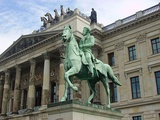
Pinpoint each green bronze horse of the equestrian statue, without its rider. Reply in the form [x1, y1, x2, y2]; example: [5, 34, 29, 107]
[61, 26, 121, 108]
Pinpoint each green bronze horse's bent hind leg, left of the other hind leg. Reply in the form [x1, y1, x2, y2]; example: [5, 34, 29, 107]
[87, 80, 96, 103]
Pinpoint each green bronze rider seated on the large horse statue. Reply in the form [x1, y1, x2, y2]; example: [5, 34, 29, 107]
[79, 27, 95, 77]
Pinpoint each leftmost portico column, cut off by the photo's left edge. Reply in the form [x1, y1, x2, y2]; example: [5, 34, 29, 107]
[0, 75, 4, 113]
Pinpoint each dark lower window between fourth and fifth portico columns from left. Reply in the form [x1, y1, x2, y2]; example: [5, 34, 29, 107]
[35, 86, 42, 106]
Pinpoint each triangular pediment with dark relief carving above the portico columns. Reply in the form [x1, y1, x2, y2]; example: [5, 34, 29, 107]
[0, 30, 61, 60]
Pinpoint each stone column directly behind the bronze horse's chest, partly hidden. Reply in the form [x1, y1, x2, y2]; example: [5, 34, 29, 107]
[58, 48, 65, 101]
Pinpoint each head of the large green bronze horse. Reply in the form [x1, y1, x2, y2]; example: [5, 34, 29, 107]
[62, 25, 72, 42]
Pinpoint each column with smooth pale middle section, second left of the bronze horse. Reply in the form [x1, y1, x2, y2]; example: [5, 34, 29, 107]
[41, 53, 50, 107]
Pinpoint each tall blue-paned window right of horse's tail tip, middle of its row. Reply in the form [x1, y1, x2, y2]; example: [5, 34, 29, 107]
[131, 76, 141, 99]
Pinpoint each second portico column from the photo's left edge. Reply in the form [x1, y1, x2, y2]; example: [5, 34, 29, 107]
[1, 70, 10, 115]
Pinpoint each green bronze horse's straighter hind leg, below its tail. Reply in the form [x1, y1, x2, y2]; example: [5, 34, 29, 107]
[101, 78, 111, 108]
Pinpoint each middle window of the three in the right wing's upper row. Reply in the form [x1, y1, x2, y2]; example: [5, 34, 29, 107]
[128, 45, 136, 61]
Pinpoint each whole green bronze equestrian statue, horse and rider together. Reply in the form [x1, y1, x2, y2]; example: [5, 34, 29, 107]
[61, 25, 121, 108]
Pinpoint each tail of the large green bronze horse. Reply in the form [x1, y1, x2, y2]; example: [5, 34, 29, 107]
[105, 64, 121, 86]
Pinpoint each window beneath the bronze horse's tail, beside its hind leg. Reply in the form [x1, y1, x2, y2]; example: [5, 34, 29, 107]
[109, 82, 118, 103]
